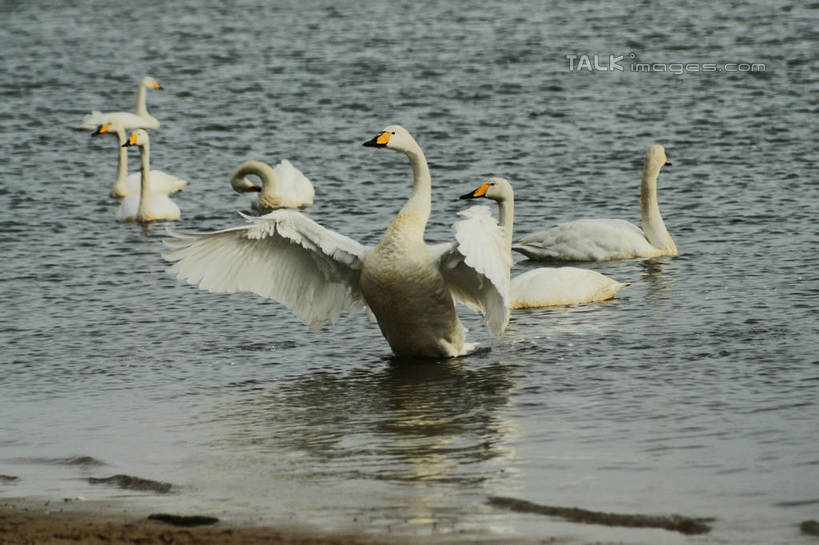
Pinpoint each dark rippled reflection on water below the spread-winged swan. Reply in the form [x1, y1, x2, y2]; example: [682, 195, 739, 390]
[201, 359, 513, 485]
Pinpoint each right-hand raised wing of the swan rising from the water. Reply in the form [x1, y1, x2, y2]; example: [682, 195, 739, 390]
[433, 206, 512, 336]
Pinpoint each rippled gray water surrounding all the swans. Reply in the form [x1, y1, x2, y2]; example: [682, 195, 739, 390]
[0, 0, 819, 544]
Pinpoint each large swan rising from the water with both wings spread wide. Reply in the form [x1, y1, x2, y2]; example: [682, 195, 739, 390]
[164, 125, 511, 357]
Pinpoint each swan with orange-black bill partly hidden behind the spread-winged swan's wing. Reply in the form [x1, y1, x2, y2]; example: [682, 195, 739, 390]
[461, 177, 630, 310]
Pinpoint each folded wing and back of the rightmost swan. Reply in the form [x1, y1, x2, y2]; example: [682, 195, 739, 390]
[512, 219, 652, 261]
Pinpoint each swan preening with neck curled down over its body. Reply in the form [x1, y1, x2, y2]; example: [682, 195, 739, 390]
[230, 159, 315, 211]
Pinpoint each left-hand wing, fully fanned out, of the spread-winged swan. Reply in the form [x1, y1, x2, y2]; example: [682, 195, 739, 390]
[163, 210, 368, 329]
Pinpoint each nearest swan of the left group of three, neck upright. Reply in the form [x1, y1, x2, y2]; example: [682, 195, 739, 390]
[117, 129, 180, 223]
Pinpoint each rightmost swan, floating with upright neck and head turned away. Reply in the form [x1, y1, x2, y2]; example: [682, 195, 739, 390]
[512, 144, 677, 261]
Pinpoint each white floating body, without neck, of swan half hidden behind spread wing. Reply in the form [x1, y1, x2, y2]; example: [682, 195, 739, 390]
[510, 267, 630, 309]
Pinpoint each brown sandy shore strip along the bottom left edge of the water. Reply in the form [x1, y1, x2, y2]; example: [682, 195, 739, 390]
[0, 500, 398, 545]
